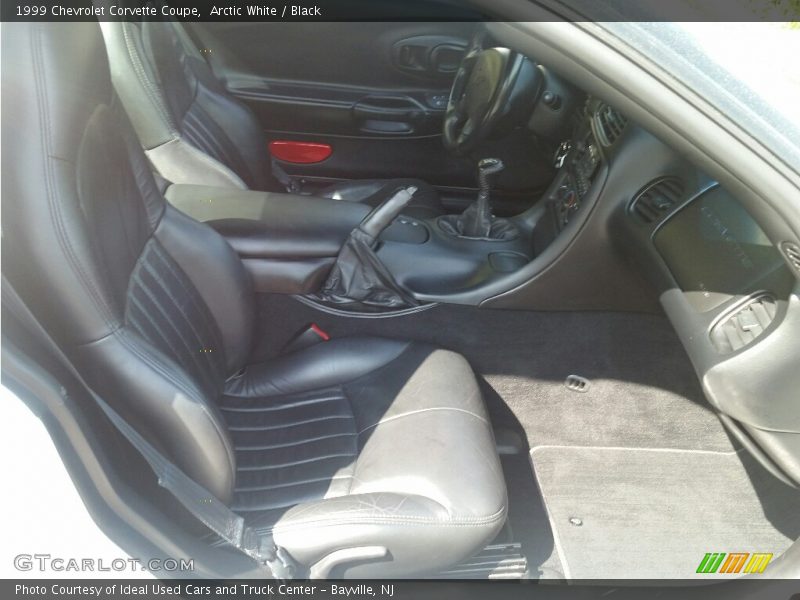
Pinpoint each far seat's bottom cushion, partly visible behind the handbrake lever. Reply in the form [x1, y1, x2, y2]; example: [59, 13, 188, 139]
[317, 179, 444, 219]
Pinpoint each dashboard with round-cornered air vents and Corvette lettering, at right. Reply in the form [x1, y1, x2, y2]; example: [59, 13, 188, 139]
[576, 98, 800, 486]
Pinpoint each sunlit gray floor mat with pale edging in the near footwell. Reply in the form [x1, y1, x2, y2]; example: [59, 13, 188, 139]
[531, 446, 800, 579]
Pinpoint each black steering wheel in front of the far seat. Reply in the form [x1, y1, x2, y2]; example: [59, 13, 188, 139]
[443, 30, 542, 155]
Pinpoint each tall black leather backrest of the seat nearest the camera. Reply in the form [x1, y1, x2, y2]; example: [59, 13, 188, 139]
[2, 23, 255, 501]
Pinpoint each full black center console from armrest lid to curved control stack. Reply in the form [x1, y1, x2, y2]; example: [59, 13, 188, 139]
[161, 100, 610, 311]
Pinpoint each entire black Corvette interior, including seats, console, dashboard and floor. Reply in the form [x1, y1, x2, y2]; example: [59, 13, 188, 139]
[2, 9, 800, 580]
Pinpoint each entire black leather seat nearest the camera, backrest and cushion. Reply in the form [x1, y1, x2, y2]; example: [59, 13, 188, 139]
[2, 23, 506, 577]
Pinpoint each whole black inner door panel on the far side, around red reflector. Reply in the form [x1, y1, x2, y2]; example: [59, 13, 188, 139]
[192, 22, 476, 187]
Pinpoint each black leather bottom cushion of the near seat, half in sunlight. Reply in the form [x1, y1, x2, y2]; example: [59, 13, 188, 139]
[221, 338, 506, 577]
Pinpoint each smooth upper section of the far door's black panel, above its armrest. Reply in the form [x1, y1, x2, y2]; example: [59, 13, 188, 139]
[192, 22, 476, 91]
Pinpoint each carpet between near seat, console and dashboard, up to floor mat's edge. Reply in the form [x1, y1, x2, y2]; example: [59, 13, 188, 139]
[256, 295, 732, 451]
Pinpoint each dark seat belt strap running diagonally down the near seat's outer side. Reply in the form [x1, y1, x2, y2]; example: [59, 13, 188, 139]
[2, 275, 296, 579]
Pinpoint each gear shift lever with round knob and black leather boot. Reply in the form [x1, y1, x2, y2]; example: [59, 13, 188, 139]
[439, 158, 517, 240]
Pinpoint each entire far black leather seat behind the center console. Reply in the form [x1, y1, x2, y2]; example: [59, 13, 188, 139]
[97, 22, 443, 218]
